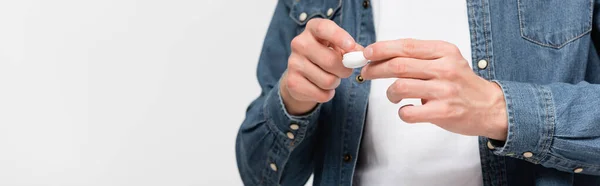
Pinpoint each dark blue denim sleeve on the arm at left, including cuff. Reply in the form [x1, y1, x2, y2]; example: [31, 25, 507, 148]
[236, 0, 320, 185]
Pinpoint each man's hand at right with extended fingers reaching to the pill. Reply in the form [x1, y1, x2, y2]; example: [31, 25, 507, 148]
[361, 39, 508, 140]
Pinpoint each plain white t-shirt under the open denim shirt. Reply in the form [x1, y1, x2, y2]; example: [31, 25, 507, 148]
[353, 0, 483, 186]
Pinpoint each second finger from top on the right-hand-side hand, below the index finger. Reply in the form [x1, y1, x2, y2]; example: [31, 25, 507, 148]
[361, 57, 439, 80]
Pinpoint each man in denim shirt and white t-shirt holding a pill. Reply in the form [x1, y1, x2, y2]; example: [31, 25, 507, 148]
[236, 0, 600, 186]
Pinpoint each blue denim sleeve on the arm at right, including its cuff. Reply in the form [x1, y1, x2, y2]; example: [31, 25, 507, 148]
[488, 2, 600, 175]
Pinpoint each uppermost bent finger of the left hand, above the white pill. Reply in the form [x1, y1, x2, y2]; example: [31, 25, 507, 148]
[306, 19, 356, 51]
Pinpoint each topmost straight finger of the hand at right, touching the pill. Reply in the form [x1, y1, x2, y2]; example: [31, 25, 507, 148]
[364, 39, 460, 61]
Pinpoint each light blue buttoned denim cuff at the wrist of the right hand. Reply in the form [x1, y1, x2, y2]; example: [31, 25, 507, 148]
[487, 81, 555, 164]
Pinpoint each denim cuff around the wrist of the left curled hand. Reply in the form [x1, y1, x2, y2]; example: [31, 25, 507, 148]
[264, 84, 321, 149]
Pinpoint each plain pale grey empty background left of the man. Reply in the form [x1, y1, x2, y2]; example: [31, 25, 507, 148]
[0, 0, 284, 186]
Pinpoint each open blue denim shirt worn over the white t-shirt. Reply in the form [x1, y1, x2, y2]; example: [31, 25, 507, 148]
[236, 0, 600, 186]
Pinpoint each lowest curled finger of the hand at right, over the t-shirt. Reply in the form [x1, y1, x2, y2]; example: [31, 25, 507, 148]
[398, 100, 450, 123]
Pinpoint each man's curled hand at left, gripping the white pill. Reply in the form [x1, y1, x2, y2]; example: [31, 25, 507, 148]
[280, 19, 362, 115]
